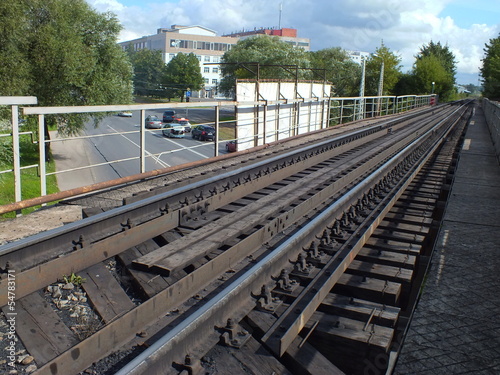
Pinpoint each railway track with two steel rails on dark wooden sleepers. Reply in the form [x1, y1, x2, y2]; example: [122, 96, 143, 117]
[0, 103, 471, 374]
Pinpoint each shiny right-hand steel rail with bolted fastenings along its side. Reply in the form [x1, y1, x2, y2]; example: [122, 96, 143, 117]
[112, 102, 468, 375]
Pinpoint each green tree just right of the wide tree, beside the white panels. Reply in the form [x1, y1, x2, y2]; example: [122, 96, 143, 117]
[309, 47, 361, 97]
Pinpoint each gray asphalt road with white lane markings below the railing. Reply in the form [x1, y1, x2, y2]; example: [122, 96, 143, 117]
[53, 108, 235, 190]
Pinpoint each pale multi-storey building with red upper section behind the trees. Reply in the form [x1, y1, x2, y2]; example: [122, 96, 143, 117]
[119, 25, 310, 98]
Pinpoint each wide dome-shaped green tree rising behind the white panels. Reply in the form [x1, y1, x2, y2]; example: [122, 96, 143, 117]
[220, 35, 312, 96]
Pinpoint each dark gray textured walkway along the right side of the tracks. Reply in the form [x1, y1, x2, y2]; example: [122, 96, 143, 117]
[393, 101, 500, 375]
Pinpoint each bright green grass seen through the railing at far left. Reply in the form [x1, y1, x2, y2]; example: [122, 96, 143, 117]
[0, 136, 59, 220]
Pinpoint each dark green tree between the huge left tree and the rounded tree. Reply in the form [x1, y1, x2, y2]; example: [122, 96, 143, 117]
[126, 44, 166, 97]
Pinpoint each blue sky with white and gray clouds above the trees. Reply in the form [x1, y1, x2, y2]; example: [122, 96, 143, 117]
[86, 0, 500, 85]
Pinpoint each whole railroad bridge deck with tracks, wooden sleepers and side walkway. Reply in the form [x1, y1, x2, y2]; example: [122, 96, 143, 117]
[0, 97, 500, 375]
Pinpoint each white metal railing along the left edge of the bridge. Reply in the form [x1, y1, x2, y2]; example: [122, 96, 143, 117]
[0, 95, 433, 206]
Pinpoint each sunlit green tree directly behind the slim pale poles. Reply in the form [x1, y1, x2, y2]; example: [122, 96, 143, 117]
[365, 42, 402, 96]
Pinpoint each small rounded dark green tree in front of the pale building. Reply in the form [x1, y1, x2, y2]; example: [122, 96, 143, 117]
[162, 53, 204, 101]
